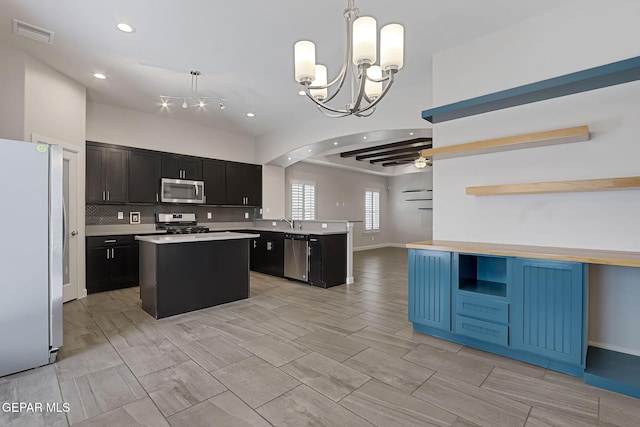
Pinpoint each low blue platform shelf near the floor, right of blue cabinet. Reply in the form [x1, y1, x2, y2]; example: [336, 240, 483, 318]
[584, 347, 640, 398]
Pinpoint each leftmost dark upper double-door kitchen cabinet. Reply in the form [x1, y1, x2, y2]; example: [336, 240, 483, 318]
[86, 143, 129, 203]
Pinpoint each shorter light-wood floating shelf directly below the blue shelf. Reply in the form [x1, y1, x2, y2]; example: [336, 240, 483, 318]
[421, 126, 590, 159]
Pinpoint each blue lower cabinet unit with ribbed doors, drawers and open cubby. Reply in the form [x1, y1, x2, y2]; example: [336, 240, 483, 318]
[409, 249, 587, 376]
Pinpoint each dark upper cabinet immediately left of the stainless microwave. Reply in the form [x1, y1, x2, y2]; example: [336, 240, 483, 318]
[129, 149, 162, 203]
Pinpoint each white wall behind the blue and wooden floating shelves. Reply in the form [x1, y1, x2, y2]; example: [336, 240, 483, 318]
[433, 0, 640, 354]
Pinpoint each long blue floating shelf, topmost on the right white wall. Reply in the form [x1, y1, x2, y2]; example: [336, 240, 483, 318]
[422, 56, 640, 123]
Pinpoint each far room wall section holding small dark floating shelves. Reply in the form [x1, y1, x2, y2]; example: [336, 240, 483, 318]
[389, 168, 433, 244]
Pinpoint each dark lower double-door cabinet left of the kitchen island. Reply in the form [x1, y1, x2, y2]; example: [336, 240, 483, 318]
[86, 235, 138, 294]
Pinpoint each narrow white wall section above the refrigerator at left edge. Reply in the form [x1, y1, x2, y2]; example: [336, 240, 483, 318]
[0, 46, 25, 141]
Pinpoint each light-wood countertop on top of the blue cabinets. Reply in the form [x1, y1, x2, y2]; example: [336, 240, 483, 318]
[406, 240, 640, 267]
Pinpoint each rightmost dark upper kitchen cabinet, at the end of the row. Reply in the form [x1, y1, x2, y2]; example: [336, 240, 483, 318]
[226, 162, 262, 206]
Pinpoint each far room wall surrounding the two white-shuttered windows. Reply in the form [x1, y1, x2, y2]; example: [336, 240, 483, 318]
[285, 162, 393, 248]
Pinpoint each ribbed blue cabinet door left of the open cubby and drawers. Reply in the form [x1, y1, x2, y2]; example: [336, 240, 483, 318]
[409, 249, 451, 331]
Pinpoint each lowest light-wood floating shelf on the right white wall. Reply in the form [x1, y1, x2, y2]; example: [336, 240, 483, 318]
[466, 176, 640, 196]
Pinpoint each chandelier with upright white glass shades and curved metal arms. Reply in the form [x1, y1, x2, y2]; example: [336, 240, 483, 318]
[294, 0, 404, 117]
